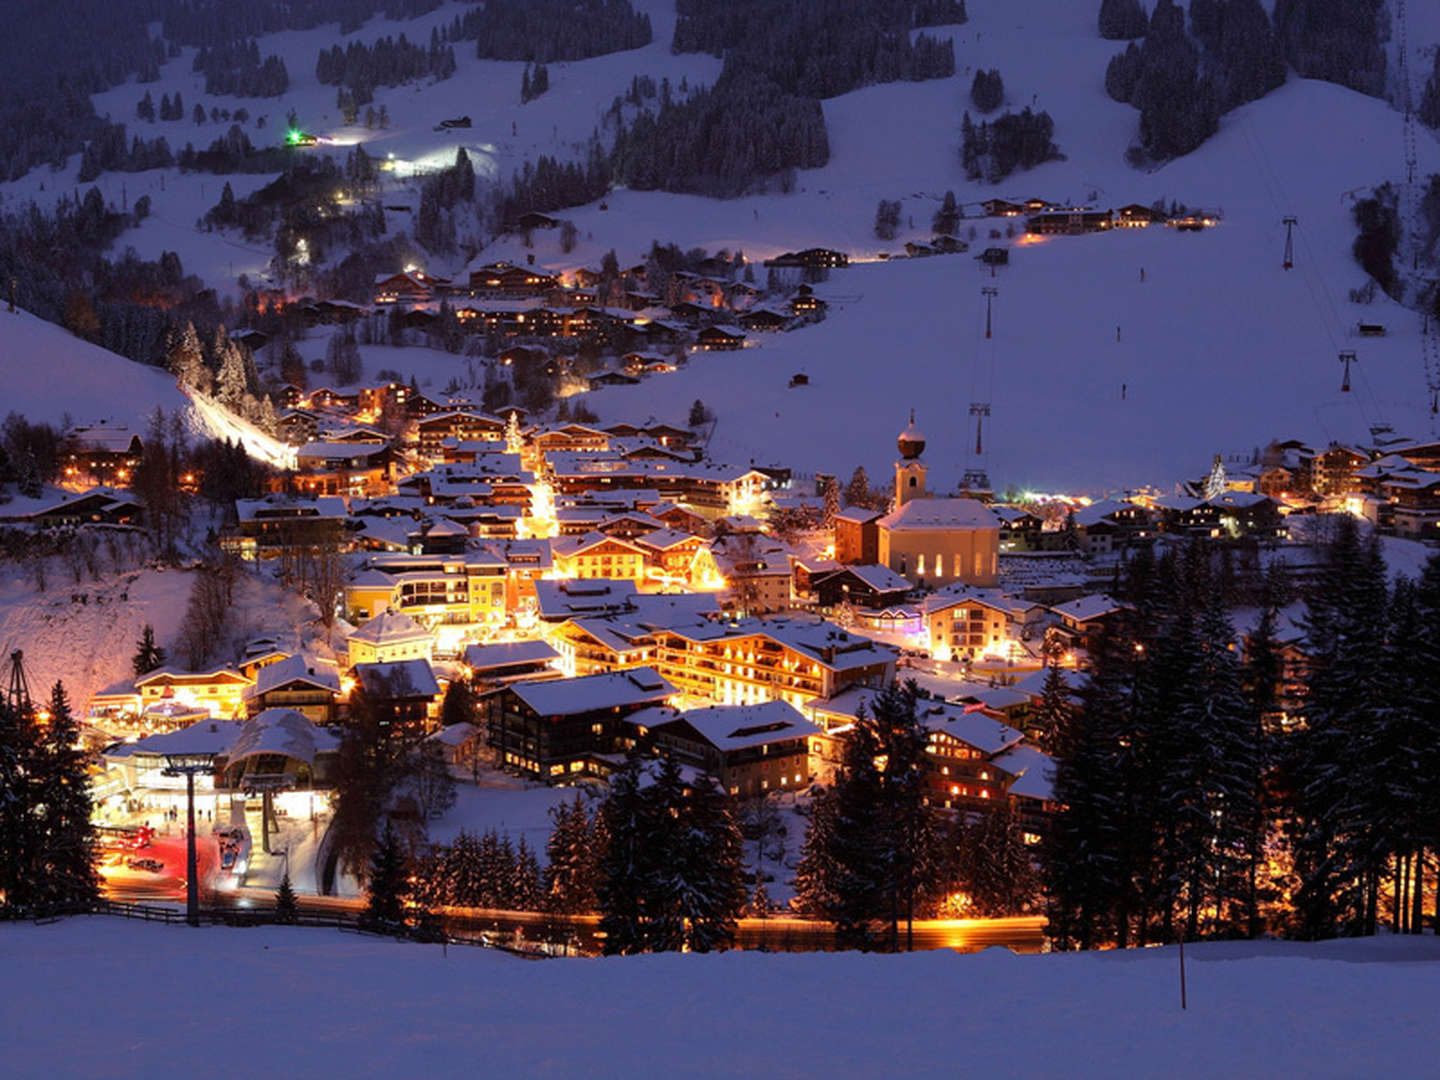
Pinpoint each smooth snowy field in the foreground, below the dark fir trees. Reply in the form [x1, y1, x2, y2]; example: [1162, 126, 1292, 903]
[0, 919, 1440, 1080]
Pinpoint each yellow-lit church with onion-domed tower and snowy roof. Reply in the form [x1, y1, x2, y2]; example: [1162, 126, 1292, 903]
[878, 412, 999, 588]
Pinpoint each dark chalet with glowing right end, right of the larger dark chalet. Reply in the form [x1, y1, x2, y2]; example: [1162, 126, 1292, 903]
[645, 701, 834, 798]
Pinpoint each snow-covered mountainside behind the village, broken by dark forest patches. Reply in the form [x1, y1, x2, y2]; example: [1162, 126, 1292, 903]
[0, 0, 1440, 490]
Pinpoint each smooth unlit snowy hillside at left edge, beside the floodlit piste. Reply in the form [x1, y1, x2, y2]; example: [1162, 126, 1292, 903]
[0, 308, 187, 432]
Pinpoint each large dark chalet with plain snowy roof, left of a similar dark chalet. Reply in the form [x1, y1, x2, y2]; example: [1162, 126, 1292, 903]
[481, 667, 675, 783]
